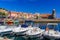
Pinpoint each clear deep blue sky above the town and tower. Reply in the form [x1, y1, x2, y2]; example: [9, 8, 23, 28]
[0, 0, 60, 18]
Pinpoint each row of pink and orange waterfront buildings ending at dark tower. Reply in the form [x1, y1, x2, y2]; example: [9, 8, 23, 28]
[0, 9, 56, 19]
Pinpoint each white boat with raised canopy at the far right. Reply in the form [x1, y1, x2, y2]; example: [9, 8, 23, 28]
[43, 23, 60, 39]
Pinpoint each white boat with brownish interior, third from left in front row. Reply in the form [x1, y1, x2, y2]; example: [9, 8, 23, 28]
[26, 26, 44, 38]
